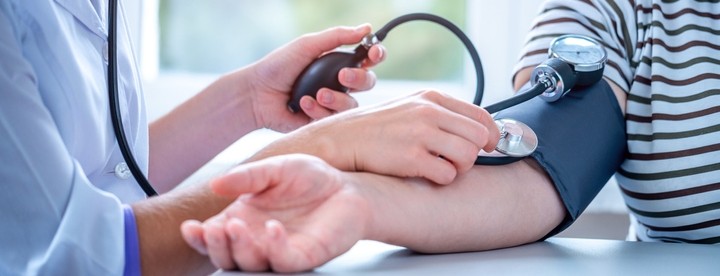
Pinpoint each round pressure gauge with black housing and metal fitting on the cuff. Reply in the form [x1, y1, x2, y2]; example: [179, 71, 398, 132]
[530, 34, 607, 102]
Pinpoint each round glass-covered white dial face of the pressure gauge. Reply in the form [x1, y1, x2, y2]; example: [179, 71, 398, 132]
[550, 35, 607, 71]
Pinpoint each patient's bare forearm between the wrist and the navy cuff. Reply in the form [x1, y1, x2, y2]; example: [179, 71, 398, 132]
[357, 161, 565, 253]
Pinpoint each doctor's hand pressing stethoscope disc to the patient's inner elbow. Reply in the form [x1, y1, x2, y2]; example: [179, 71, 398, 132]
[253, 91, 500, 184]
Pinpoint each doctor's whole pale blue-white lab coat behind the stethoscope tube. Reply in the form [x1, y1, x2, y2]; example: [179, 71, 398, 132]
[0, 0, 148, 275]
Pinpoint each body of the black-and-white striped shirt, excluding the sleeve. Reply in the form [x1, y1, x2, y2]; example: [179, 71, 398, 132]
[616, 0, 720, 244]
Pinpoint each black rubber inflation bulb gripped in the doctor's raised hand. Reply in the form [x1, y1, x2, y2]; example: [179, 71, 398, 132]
[288, 45, 368, 113]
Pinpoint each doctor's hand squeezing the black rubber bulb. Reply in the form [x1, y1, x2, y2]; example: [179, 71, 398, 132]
[249, 24, 385, 132]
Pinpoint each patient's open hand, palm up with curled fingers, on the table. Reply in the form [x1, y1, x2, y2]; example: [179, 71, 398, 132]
[181, 155, 370, 272]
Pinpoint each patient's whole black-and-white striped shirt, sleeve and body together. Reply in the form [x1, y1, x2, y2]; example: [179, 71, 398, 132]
[515, 0, 720, 243]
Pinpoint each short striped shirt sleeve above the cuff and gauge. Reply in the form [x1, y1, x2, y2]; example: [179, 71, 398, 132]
[513, 0, 637, 91]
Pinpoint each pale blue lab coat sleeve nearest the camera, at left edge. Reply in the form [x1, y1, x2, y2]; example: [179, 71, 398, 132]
[0, 4, 125, 275]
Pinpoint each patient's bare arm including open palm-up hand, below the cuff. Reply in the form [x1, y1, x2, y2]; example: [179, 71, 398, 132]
[183, 70, 624, 272]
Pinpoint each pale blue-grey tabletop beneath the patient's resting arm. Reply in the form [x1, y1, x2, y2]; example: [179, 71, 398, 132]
[216, 238, 720, 276]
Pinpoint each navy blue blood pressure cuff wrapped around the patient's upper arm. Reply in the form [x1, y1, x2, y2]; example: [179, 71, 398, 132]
[495, 80, 626, 238]
